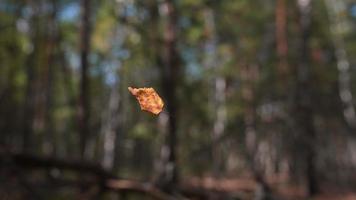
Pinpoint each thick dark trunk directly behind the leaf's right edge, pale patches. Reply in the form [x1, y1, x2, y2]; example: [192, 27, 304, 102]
[157, 0, 180, 192]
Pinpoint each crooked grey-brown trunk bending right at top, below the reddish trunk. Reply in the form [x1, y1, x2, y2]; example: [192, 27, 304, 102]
[241, 19, 274, 200]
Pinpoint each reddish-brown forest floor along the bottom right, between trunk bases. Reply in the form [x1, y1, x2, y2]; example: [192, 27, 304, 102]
[183, 177, 356, 200]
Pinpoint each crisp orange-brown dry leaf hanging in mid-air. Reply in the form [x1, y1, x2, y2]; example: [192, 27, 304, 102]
[128, 87, 164, 115]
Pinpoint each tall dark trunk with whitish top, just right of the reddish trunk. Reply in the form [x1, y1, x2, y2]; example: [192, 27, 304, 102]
[294, 0, 319, 196]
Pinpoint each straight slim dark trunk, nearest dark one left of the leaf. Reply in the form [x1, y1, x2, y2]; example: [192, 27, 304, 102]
[78, 0, 90, 158]
